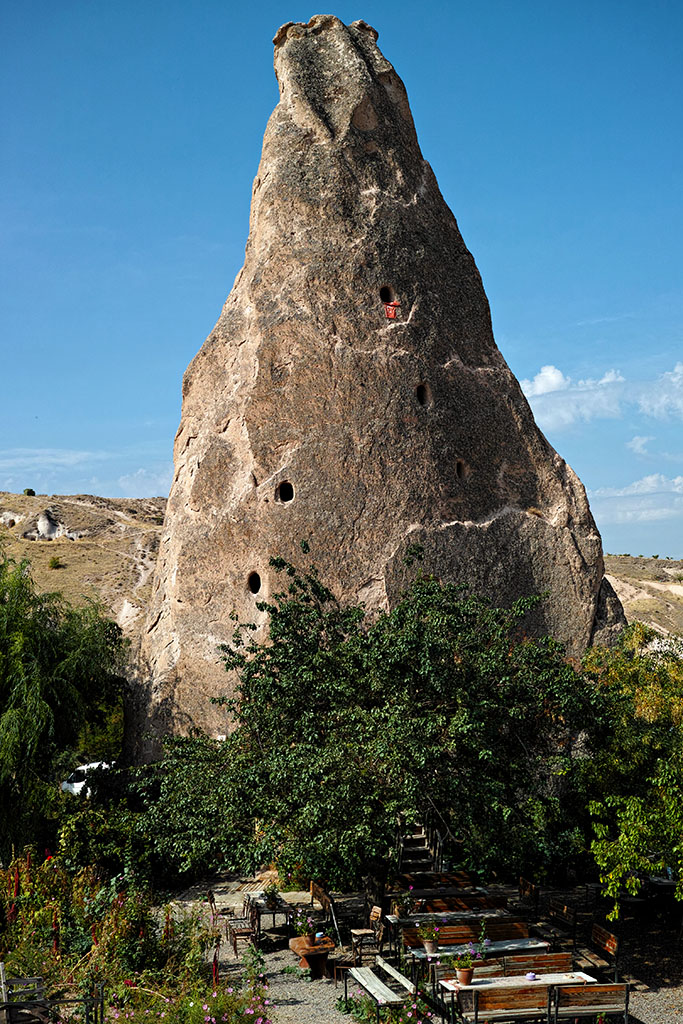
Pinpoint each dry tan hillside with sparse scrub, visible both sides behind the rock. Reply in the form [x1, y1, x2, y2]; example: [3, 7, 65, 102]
[0, 492, 683, 636]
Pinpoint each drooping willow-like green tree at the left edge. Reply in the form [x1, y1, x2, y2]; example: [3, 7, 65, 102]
[0, 552, 125, 859]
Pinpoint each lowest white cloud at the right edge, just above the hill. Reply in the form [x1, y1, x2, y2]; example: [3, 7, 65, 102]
[589, 473, 683, 524]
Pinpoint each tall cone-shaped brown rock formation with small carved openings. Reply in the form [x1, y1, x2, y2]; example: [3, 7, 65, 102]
[136, 15, 624, 753]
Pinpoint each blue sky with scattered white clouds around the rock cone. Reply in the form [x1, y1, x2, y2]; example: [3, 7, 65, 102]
[0, 0, 683, 557]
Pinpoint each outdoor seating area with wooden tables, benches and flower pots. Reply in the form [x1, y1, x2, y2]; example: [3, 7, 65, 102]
[192, 856, 683, 1024]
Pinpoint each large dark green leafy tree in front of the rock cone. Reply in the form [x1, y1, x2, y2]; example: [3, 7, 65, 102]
[205, 559, 603, 885]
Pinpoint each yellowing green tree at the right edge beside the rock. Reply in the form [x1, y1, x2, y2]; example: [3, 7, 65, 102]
[585, 623, 683, 918]
